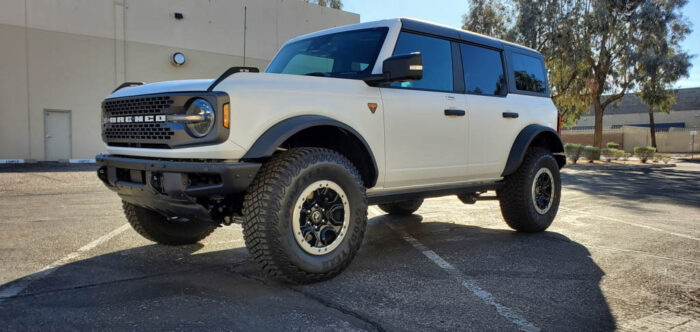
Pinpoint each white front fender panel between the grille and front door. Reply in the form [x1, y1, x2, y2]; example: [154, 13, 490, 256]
[217, 73, 385, 186]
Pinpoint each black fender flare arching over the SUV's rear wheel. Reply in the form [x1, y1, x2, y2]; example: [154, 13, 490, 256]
[501, 124, 566, 177]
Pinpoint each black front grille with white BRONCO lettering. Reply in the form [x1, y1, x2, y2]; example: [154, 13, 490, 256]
[102, 91, 229, 149]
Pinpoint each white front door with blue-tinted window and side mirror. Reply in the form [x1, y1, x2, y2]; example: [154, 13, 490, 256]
[381, 32, 468, 188]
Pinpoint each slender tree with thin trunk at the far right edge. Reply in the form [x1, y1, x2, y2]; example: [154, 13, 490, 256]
[635, 0, 690, 147]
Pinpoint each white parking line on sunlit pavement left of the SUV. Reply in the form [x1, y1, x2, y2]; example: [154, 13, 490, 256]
[0, 224, 129, 303]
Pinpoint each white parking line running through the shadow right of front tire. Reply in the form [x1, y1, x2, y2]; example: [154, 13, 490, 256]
[369, 206, 540, 332]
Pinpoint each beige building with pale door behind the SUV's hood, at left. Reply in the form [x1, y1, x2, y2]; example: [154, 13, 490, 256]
[0, 0, 360, 161]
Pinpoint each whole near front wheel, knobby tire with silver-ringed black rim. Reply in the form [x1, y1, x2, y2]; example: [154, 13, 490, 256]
[243, 148, 367, 284]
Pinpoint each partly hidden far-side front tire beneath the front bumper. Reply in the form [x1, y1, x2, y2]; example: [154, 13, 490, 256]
[122, 201, 216, 246]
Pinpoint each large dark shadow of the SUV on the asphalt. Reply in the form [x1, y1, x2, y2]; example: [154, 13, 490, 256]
[0, 215, 615, 331]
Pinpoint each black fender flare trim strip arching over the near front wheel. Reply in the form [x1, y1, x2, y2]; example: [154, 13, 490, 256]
[241, 115, 379, 188]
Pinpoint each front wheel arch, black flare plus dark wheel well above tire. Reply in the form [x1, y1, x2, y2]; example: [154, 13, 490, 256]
[242, 115, 379, 188]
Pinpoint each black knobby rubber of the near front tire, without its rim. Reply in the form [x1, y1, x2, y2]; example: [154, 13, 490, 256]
[243, 147, 367, 284]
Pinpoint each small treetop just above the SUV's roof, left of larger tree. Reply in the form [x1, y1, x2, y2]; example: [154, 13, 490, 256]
[462, 0, 510, 39]
